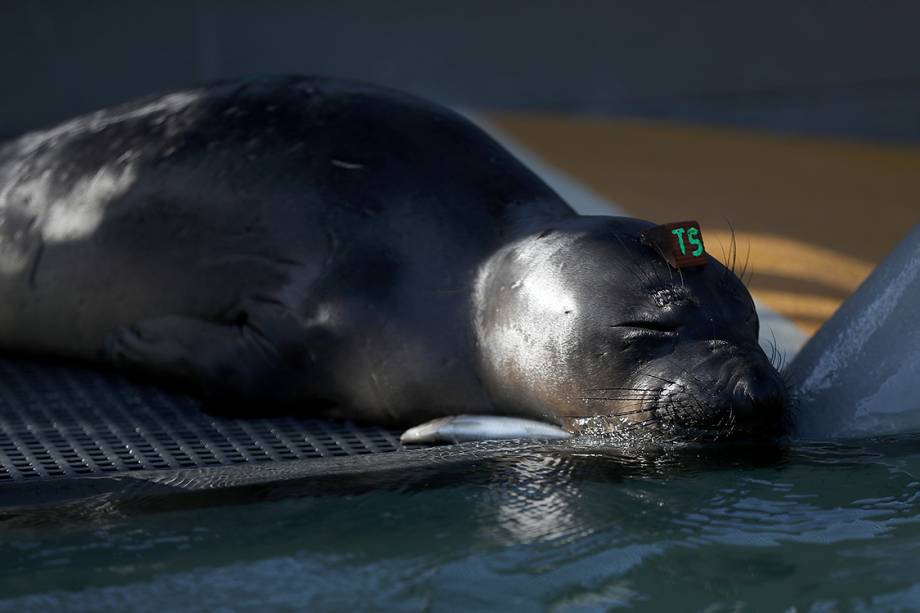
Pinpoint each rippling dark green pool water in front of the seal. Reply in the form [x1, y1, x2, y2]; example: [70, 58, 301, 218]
[0, 436, 920, 611]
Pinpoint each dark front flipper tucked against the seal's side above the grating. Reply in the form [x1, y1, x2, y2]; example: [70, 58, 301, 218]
[103, 298, 306, 412]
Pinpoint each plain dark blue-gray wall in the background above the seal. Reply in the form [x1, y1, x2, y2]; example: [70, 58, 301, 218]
[0, 0, 920, 140]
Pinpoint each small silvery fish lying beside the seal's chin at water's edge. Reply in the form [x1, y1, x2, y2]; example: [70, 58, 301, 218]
[399, 415, 572, 445]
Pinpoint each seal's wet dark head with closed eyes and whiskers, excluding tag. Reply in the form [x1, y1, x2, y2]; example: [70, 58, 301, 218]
[476, 217, 788, 440]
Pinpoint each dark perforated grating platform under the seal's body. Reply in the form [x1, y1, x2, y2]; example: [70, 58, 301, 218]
[0, 358, 401, 483]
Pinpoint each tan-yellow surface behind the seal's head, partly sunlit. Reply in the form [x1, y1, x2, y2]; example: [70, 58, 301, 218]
[488, 113, 920, 334]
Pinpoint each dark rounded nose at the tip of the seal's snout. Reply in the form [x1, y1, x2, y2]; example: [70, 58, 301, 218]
[732, 372, 787, 437]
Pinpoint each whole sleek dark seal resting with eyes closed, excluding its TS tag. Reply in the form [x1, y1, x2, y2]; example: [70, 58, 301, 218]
[0, 77, 786, 438]
